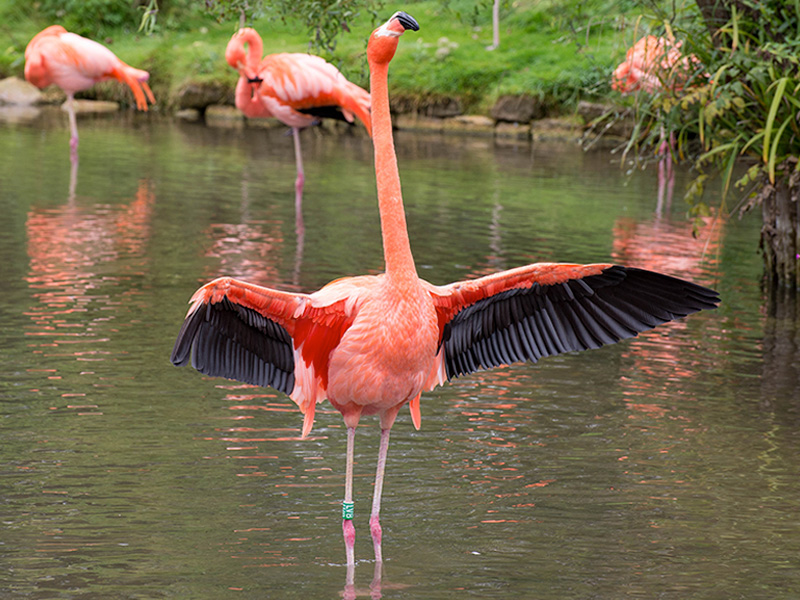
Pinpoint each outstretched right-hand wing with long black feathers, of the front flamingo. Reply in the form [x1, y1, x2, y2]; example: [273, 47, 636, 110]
[424, 263, 719, 380]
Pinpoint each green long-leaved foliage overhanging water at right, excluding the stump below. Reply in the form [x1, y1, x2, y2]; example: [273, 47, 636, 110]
[608, 0, 800, 216]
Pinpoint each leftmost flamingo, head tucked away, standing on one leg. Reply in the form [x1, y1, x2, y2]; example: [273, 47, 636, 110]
[25, 25, 156, 160]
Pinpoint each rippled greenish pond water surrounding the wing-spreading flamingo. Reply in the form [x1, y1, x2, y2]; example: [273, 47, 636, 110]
[0, 109, 800, 599]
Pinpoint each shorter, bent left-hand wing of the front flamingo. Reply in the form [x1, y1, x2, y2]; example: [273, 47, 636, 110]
[171, 277, 376, 437]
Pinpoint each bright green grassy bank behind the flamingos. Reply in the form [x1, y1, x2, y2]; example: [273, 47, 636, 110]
[0, 0, 631, 114]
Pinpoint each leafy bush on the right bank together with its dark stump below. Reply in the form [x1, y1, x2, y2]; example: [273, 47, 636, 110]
[608, 0, 800, 289]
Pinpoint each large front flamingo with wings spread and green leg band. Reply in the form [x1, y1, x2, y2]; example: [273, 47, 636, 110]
[171, 12, 719, 580]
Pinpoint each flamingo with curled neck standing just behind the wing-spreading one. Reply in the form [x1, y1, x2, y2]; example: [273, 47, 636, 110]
[225, 27, 371, 209]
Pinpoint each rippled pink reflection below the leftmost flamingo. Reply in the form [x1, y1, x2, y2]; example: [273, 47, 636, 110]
[25, 178, 155, 360]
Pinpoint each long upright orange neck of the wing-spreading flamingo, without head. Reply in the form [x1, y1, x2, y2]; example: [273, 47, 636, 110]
[370, 63, 417, 278]
